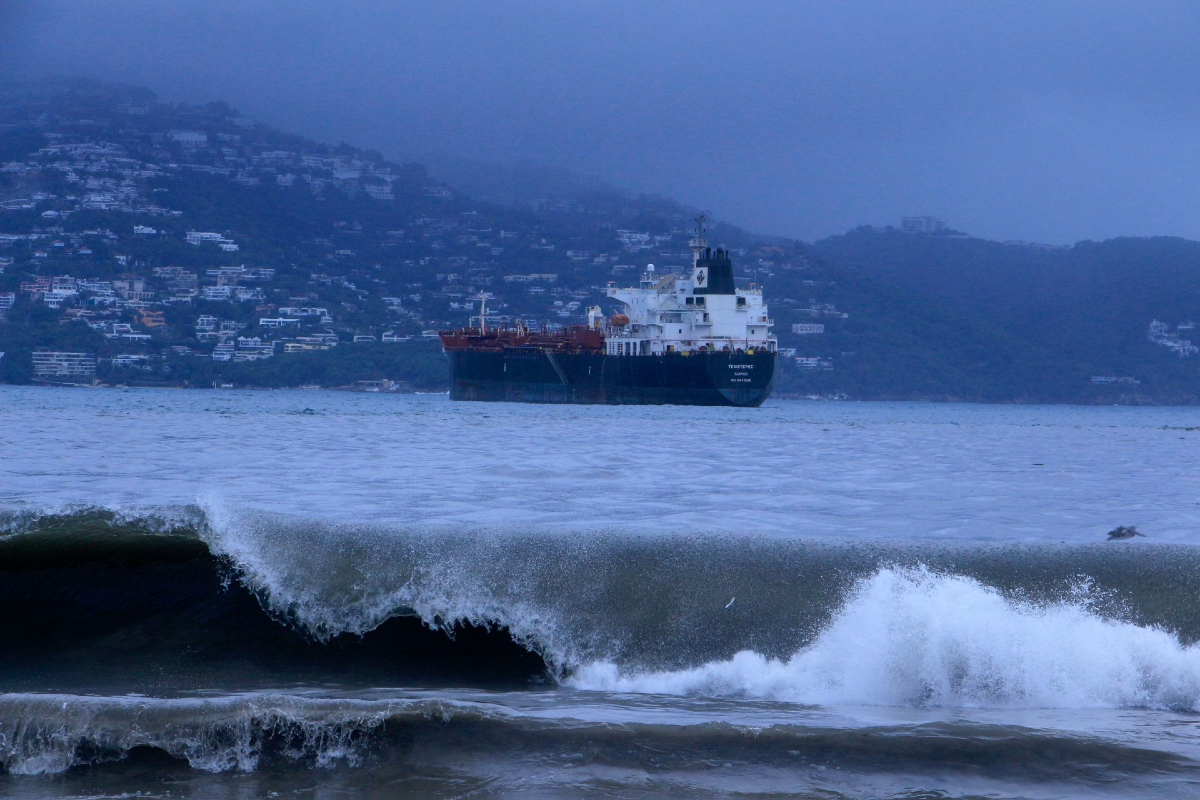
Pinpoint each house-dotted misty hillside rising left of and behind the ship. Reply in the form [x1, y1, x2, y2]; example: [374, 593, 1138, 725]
[0, 82, 751, 389]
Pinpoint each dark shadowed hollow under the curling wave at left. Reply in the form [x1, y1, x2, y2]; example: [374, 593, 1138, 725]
[0, 510, 546, 693]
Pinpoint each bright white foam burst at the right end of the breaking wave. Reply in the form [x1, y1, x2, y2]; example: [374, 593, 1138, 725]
[569, 569, 1200, 710]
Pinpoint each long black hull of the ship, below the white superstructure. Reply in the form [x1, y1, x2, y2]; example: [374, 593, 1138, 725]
[446, 348, 775, 408]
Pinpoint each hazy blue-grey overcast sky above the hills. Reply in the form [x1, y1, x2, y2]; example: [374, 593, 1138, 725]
[0, 0, 1200, 243]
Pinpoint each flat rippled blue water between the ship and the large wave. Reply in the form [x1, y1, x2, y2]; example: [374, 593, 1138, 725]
[7, 387, 1200, 543]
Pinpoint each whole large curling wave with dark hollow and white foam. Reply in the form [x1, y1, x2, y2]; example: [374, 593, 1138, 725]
[0, 501, 1200, 710]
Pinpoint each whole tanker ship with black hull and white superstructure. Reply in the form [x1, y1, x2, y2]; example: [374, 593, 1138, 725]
[438, 216, 779, 408]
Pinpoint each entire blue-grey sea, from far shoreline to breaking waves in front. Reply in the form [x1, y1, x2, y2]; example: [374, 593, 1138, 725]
[0, 387, 1200, 800]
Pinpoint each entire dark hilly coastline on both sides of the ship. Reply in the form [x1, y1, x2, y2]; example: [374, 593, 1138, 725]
[0, 80, 1200, 403]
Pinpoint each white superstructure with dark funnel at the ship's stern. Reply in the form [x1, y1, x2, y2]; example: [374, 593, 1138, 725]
[600, 215, 778, 355]
